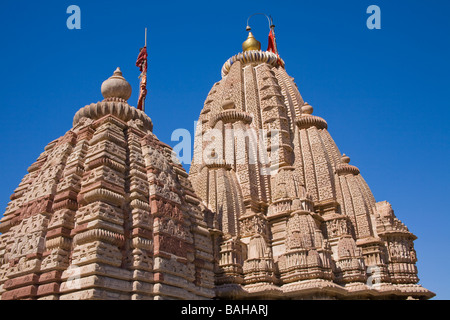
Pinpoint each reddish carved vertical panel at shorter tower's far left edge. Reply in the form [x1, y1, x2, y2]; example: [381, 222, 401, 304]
[2, 131, 75, 300]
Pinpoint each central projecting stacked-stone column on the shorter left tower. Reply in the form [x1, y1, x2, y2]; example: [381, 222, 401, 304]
[60, 115, 131, 299]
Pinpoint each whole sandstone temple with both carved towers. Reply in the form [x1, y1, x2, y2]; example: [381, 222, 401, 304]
[0, 33, 434, 300]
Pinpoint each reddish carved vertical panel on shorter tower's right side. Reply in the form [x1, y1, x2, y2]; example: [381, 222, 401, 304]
[145, 135, 195, 299]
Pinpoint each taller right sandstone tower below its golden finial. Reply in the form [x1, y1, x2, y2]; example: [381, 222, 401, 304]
[189, 51, 434, 299]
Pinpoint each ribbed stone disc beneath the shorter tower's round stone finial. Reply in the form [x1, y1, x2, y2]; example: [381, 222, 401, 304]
[73, 98, 153, 131]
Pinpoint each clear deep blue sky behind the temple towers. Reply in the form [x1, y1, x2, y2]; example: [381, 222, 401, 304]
[0, 0, 450, 299]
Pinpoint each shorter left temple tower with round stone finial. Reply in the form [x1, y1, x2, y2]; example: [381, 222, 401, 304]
[0, 70, 214, 300]
